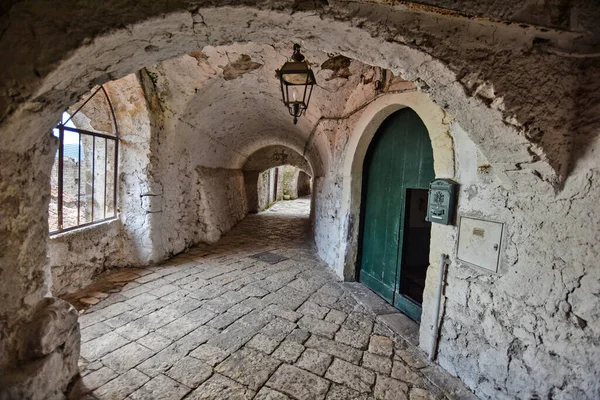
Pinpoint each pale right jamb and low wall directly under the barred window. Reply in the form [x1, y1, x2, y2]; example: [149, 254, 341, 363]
[47, 74, 161, 295]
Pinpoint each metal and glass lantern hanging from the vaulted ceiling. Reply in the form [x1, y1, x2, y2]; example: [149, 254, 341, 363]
[279, 44, 316, 125]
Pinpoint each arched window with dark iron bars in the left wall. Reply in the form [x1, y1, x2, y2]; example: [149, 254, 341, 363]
[48, 86, 119, 234]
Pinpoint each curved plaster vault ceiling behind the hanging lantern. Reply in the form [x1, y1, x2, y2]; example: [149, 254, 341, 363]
[142, 42, 381, 175]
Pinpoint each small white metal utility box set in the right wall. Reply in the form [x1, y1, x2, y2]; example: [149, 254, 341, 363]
[457, 216, 504, 272]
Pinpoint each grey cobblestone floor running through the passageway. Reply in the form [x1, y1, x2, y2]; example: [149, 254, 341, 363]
[80, 199, 464, 400]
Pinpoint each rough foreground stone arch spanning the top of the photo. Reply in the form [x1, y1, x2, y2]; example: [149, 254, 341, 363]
[0, 0, 598, 184]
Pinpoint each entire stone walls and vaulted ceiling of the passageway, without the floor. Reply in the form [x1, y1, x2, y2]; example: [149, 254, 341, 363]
[0, 1, 600, 398]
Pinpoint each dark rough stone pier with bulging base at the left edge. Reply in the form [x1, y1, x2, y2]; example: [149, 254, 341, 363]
[0, 134, 80, 400]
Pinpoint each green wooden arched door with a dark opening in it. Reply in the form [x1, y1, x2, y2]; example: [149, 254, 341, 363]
[359, 108, 434, 321]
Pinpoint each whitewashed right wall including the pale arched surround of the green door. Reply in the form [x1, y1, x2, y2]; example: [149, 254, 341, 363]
[315, 92, 600, 399]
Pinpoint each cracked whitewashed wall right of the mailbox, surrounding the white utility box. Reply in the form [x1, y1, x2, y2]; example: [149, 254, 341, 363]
[432, 123, 600, 399]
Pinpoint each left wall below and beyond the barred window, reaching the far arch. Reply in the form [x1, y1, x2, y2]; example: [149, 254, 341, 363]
[48, 71, 247, 295]
